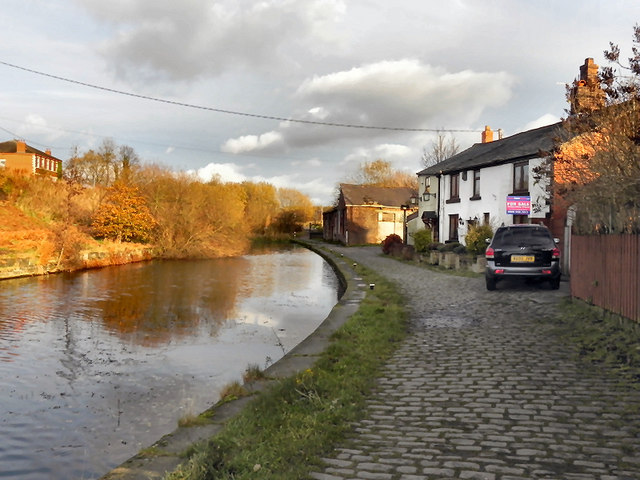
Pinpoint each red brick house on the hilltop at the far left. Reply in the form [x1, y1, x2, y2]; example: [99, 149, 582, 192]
[0, 140, 62, 178]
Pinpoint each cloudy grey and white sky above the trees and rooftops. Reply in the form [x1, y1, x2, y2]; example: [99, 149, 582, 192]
[0, 0, 640, 205]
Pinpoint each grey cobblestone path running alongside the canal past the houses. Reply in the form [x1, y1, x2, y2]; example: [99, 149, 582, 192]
[312, 246, 640, 480]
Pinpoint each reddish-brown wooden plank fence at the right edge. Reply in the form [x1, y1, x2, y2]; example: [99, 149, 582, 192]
[571, 235, 640, 322]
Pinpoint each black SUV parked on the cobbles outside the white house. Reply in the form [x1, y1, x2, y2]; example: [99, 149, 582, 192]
[485, 225, 560, 290]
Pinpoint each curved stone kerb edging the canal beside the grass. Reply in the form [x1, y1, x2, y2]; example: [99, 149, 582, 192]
[100, 240, 367, 480]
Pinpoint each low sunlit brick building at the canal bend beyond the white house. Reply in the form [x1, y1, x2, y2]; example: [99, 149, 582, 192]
[323, 183, 418, 245]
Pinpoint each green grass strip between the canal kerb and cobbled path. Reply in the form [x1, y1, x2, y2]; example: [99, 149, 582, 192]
[165, 267, 407, 480]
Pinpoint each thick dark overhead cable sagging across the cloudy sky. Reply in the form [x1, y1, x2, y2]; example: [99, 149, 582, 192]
[0, 60, 480, 133]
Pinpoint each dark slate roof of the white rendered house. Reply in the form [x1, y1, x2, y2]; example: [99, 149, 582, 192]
[418, 122, 567, 175]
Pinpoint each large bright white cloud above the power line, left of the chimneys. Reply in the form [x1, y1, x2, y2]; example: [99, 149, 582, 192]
[296, 59, 514, 128]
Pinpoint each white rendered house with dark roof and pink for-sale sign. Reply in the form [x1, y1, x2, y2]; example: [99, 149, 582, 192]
[418, 123, 562, 244]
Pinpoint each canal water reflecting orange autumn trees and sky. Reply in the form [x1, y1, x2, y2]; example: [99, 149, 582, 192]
[0, 247, 339, 480]
